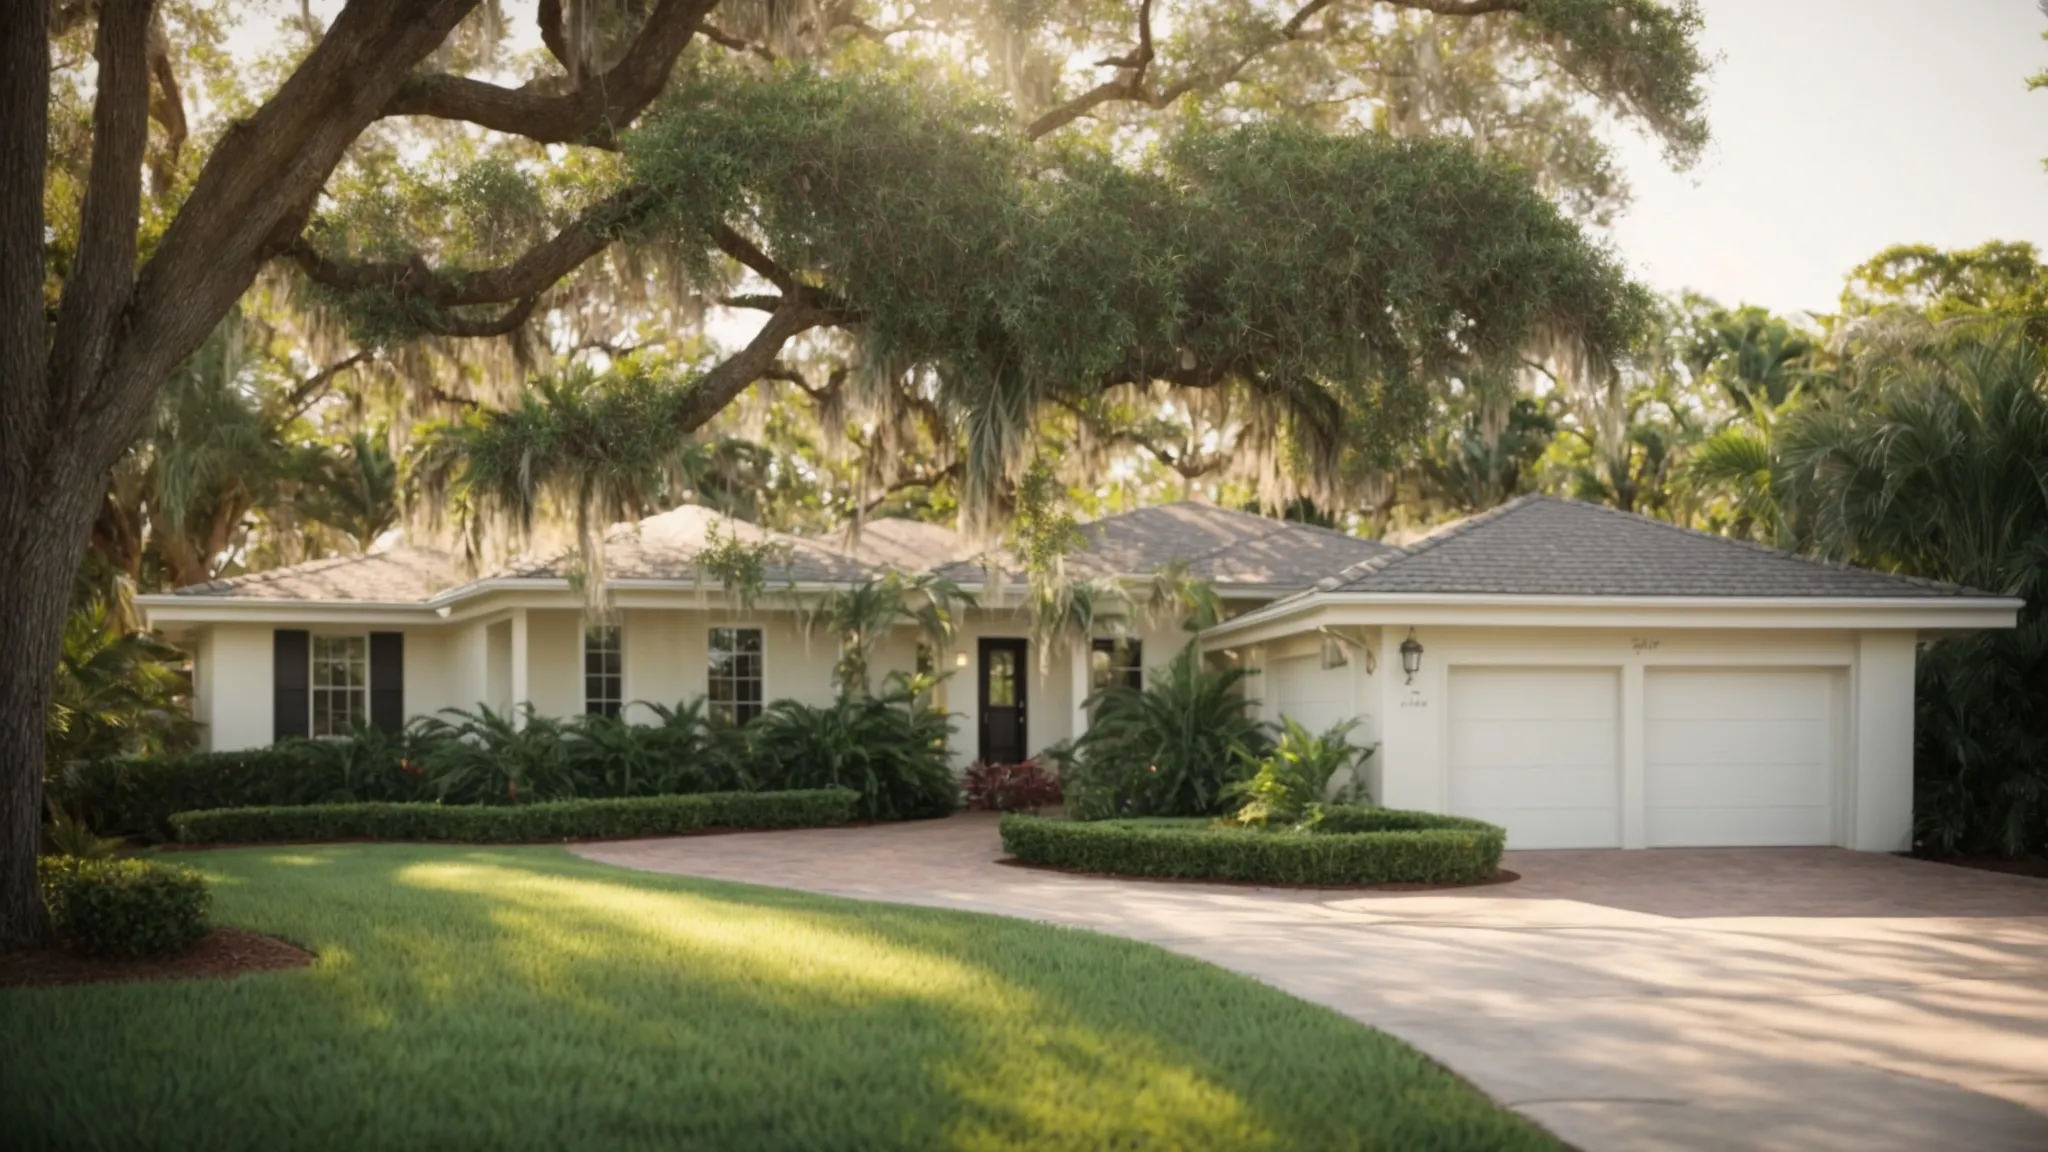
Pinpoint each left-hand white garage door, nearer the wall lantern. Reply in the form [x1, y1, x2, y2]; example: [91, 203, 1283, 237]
[1450, 668, 1622, 849]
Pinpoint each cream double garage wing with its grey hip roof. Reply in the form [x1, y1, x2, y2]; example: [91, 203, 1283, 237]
[1200, 487, 2021, 853]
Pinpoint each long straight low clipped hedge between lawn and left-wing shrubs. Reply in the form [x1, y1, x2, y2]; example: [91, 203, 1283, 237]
[170, 787, 860, 845]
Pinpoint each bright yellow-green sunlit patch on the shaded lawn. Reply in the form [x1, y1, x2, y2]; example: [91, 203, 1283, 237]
[395, 859, 1278, 1148]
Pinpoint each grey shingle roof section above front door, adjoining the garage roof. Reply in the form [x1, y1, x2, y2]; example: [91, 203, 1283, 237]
[940, 502, 1393, 590]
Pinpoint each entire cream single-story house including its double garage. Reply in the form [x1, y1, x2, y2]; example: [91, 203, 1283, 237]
[139, 487, 2021, 851]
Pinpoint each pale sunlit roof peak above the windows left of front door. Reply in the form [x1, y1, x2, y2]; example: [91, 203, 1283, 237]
[504, 504, 877, 584]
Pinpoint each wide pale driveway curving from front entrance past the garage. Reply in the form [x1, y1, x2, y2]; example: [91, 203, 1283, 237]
[575, 814, 2048, 1152]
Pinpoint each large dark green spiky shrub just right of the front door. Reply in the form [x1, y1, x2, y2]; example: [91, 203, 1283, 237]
[1055, 644, 1272, 820]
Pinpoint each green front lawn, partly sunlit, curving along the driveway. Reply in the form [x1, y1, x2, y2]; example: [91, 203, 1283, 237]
[0, 845, 1556, 1152]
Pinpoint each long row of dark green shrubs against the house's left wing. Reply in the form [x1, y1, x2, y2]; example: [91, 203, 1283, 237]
[66, 681, 956, 828]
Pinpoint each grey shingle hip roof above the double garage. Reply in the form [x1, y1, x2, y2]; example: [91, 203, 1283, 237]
[1317, 496, 1982, 599]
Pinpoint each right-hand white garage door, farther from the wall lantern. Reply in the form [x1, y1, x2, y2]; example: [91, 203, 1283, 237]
[1642, 668, 1835, 847]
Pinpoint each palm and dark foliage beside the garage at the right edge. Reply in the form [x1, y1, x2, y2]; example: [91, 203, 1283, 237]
[1778, 318, 2048, 853]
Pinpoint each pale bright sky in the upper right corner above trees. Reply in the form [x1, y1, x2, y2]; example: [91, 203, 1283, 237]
[1614, 0, 2048, 312]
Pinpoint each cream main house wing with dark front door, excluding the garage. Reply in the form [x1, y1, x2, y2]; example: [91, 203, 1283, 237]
[137, 504, 1391, 769]
